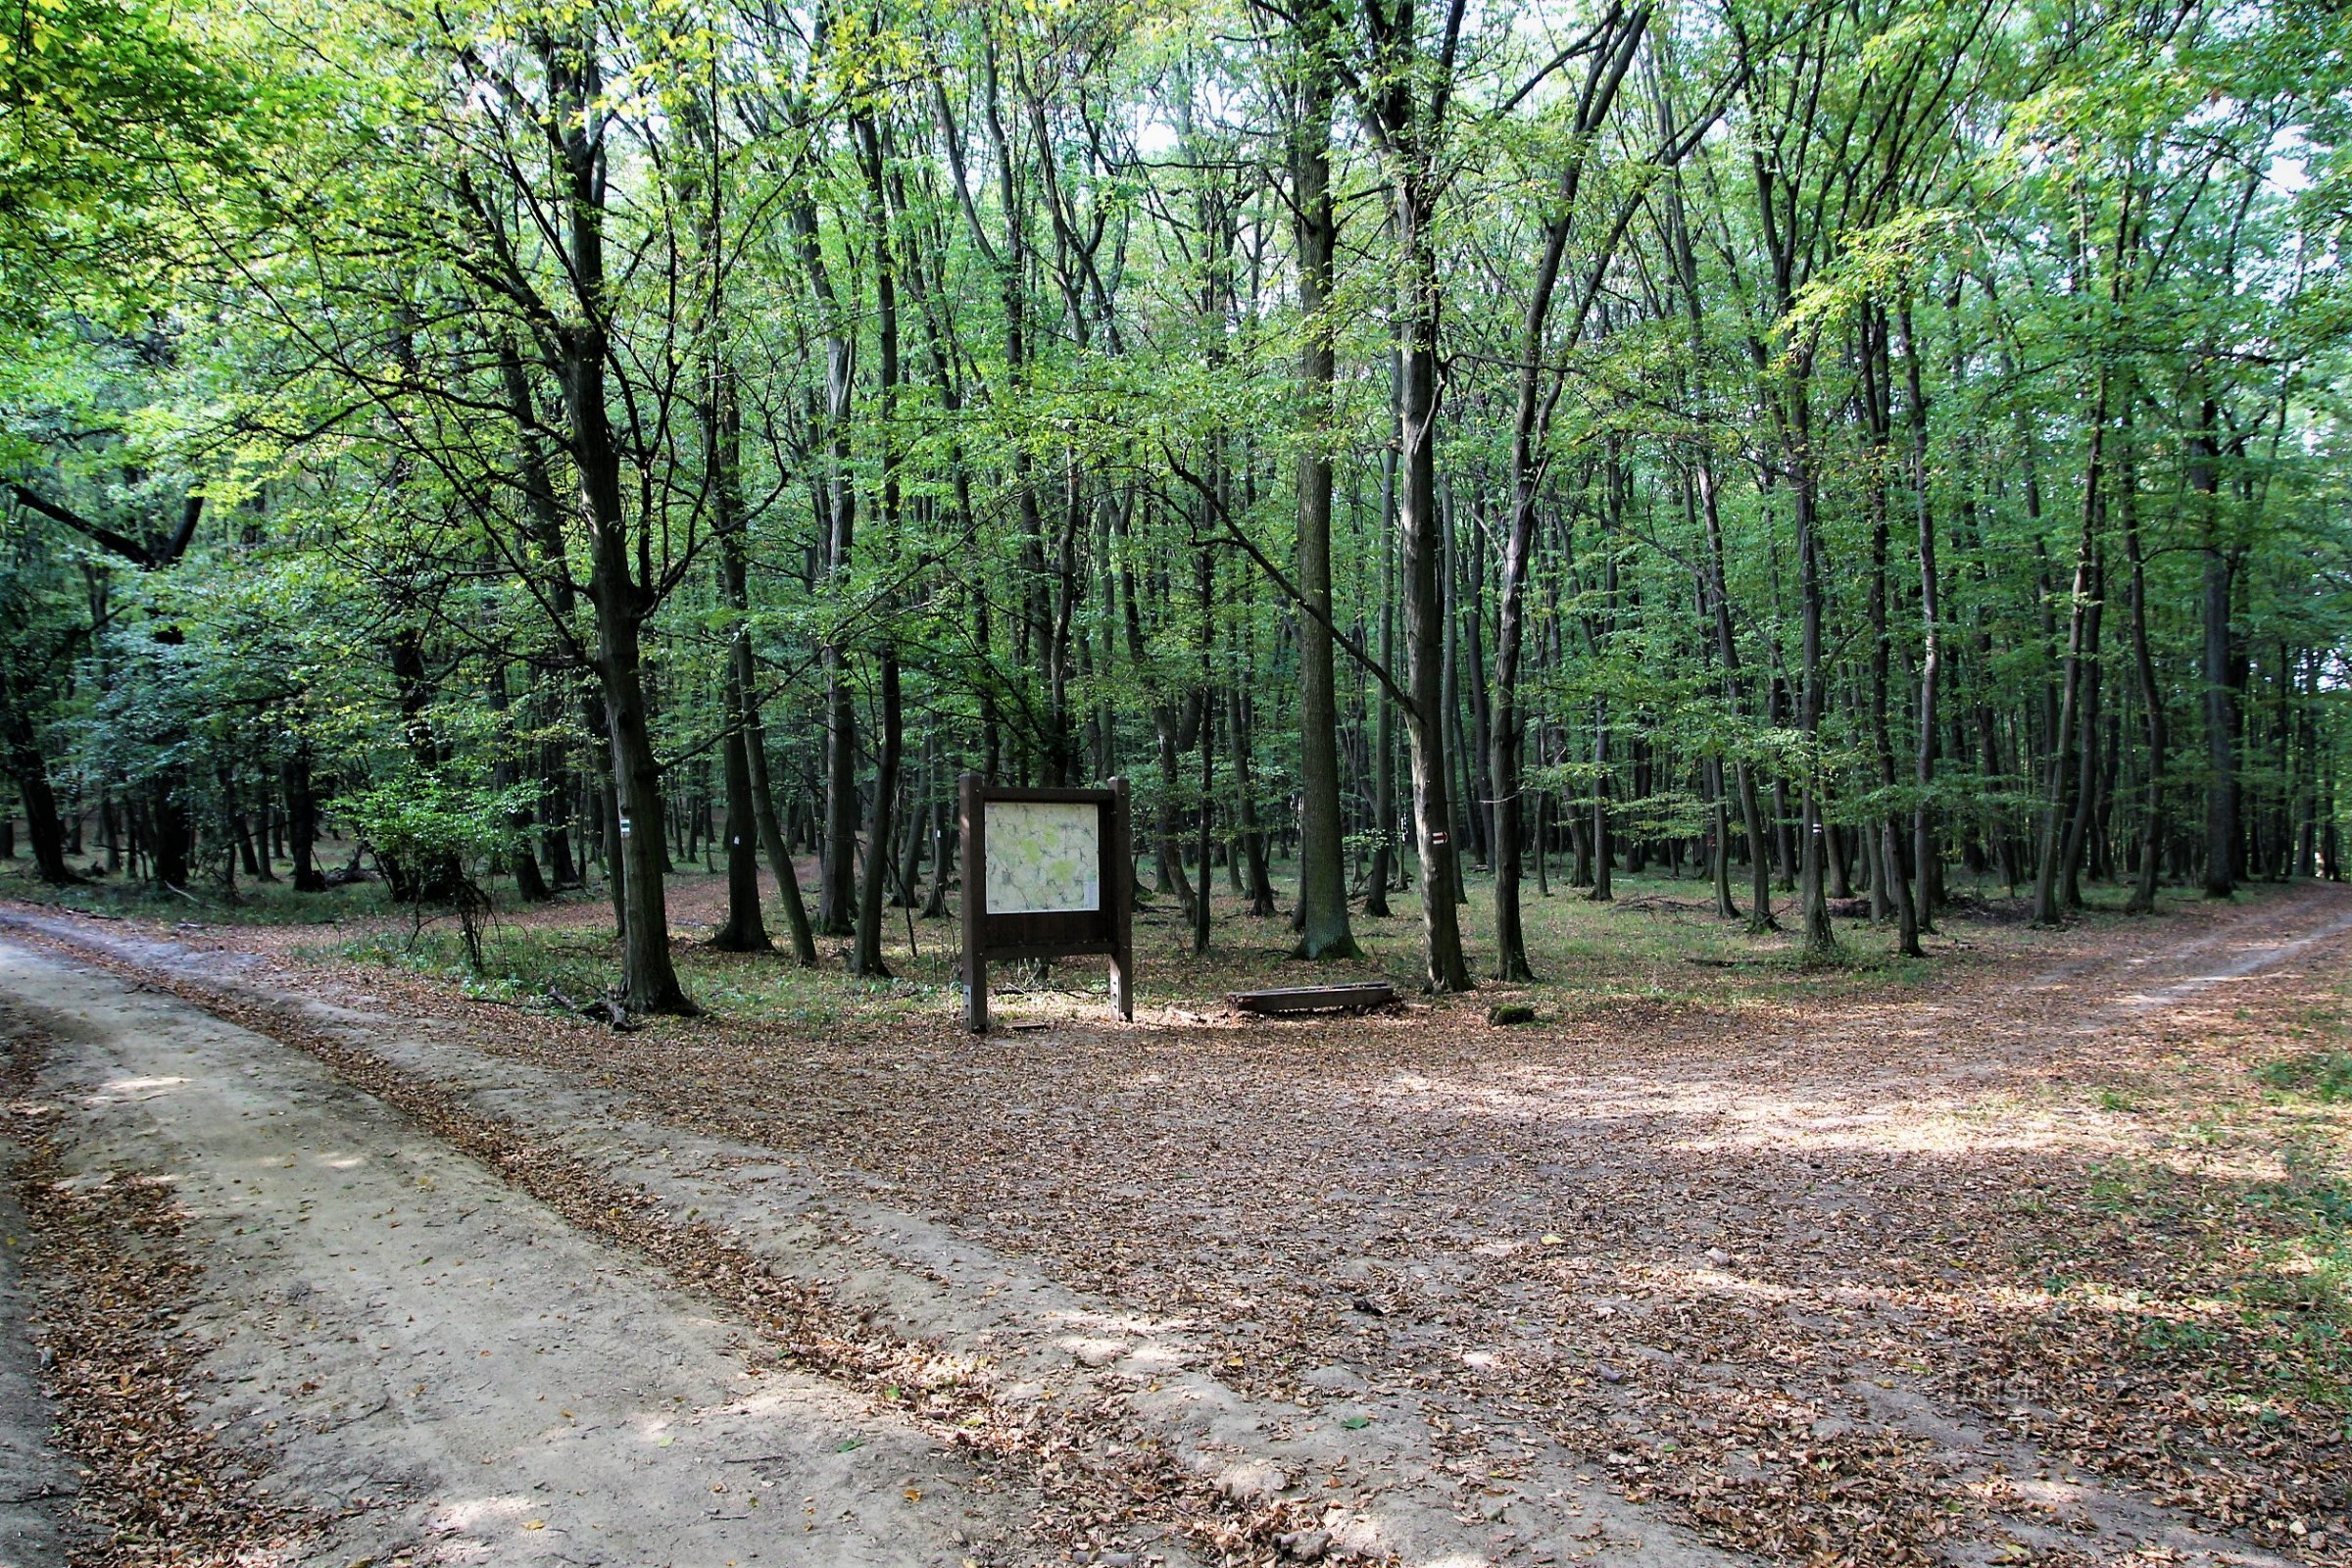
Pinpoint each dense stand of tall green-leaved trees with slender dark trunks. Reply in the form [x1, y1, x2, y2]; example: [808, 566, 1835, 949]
[0, 0, 2352, 1013]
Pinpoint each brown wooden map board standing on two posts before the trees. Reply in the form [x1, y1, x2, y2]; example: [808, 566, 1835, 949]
[957, 773, 1136, 1034]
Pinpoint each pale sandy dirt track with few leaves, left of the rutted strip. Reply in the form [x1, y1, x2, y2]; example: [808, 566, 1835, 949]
[0, 945, 1028, 1568]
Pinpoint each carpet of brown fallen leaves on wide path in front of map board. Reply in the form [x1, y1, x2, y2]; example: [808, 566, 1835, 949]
[18, 889, 2352, 1568]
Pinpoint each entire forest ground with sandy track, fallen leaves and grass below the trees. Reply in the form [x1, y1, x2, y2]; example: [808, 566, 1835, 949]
[0, 859, 2352, 1568]
